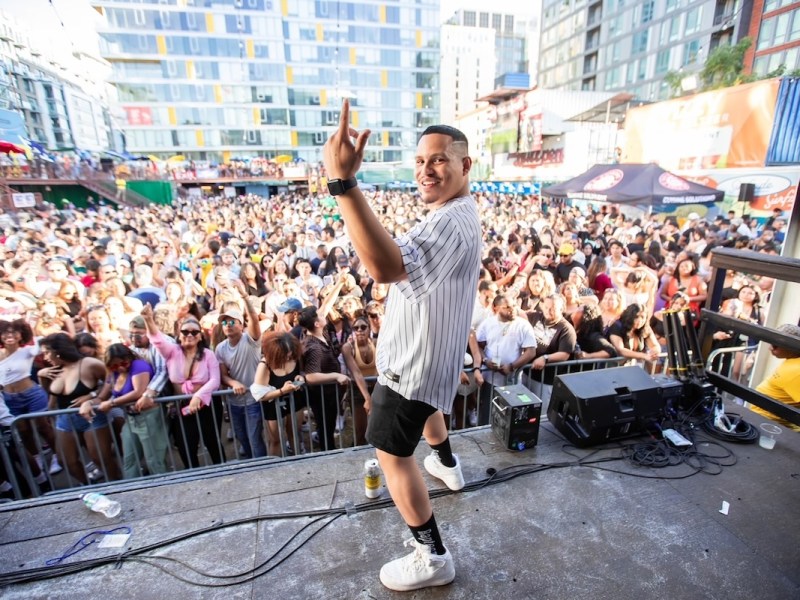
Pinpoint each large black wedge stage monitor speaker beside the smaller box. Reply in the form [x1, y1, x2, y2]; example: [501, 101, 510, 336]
[547, 367, 665, 448]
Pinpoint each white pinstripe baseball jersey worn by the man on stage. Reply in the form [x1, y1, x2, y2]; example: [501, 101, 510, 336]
[377, 196, 481, 413]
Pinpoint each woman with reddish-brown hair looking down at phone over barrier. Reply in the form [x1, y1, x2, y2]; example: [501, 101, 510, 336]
[250, 332, 306, 456]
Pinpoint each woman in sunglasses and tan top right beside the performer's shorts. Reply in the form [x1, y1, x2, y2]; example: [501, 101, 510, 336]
[342, 313, 378, 446]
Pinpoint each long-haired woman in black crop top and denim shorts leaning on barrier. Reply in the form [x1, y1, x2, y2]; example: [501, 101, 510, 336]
[39, 333, 121, 484]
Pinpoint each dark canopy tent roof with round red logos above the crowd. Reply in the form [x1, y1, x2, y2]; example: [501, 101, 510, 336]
[542, 164, 725, 205]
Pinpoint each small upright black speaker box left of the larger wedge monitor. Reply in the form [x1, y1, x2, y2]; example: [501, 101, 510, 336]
[491, 385, 542, 450]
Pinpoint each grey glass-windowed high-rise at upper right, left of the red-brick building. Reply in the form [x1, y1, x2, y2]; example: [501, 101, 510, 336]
[539, 0, 749, 100]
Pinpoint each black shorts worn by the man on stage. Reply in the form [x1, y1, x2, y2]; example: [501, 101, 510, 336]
[367, 383, 436, 457]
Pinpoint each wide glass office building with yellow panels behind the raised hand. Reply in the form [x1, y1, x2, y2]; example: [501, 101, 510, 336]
[97, 0, 439, 162]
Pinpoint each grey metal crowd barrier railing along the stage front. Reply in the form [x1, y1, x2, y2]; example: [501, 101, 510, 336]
[0, 359, 636, 499]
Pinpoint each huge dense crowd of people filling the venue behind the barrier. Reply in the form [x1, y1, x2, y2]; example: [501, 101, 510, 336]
[0, 186, 786, 492]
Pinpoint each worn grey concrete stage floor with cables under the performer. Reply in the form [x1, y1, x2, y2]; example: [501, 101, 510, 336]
[0, 407, 800, 600]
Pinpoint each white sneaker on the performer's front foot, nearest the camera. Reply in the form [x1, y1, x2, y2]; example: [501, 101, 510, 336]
[381, 539, 456, 592]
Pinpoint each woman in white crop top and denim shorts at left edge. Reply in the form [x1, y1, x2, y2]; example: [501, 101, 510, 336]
[0, 319, 61, 474]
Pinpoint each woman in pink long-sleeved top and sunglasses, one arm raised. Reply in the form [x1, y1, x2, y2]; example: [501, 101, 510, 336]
[142, 304, 225, 468]
